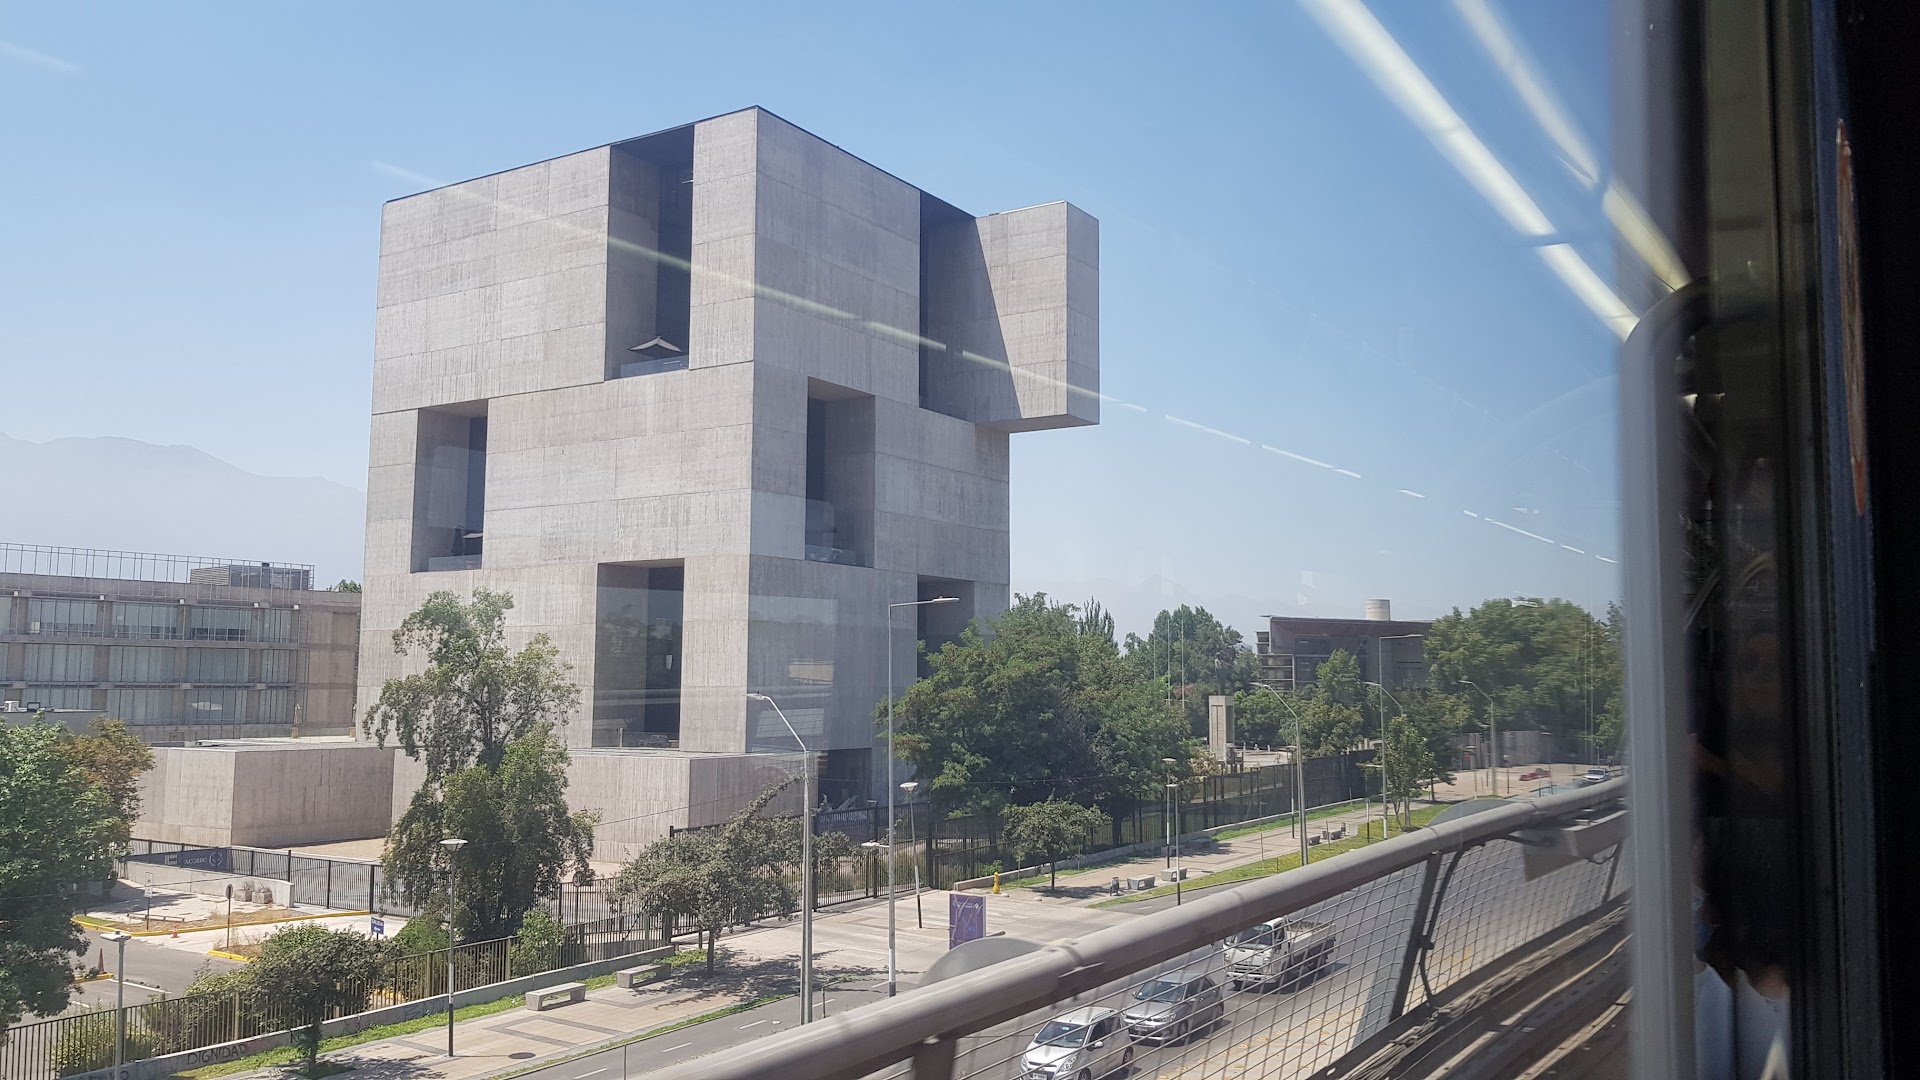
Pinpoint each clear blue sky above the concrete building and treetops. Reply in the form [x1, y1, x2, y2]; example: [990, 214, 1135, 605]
[0, 0, 1619, 632]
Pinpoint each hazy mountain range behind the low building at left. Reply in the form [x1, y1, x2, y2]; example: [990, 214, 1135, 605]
[0, 434, 367, 586]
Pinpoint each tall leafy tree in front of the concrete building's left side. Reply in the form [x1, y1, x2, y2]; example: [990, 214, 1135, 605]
[367, 590, 593, 938]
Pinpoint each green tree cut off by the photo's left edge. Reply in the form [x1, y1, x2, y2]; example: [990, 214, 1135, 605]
[0, 723, 127, 1026]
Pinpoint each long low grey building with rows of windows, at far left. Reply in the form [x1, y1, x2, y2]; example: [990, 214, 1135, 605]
[0, 544, 361, 742]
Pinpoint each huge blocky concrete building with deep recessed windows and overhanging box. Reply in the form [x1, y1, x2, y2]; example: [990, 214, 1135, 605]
[359, 108, 1100, 844]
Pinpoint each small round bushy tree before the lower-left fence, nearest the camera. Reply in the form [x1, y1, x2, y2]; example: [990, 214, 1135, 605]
[248, 924, 386, 1074]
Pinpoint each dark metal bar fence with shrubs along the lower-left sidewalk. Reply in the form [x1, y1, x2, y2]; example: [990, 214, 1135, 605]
[0, 917, 662, 1080]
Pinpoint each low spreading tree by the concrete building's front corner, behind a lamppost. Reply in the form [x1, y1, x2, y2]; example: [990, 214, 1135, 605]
[611, 780, 852, 974]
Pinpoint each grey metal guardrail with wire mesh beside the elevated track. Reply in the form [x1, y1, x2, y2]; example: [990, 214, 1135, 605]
[655, 780, 1628, 1080]
